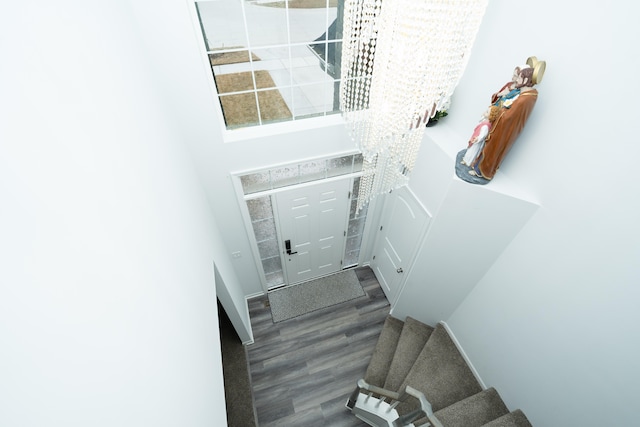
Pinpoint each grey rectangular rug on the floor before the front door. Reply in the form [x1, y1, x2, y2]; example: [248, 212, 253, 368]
[268, 270, 364, 323]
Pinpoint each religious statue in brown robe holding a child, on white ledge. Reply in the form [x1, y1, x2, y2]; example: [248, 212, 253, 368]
[456, 56, 546, 185]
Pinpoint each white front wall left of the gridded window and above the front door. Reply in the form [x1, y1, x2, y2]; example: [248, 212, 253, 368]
[165, 0, 354, 300]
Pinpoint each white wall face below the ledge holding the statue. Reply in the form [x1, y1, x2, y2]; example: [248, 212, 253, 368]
[391, 174, 538, 325]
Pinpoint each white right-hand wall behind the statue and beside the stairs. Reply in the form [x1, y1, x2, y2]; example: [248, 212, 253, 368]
[402, 0, 640, 426]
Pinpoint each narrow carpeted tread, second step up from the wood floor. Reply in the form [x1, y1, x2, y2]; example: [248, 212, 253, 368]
[384, 317, 434, 391]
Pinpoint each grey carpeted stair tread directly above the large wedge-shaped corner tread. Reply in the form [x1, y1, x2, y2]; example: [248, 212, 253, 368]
[435, 388, 509, 427]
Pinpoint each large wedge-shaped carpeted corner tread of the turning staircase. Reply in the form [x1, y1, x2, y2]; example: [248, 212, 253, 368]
[398, 324, 482, 413]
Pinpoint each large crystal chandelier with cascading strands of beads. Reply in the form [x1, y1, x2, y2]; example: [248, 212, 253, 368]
[340, 0, 487, 210]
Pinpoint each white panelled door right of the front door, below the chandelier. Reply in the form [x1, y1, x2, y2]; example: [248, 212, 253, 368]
[371, 187, 430, 305]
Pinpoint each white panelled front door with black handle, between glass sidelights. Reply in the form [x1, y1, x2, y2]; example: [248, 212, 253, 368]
[276, 179, 351, 284]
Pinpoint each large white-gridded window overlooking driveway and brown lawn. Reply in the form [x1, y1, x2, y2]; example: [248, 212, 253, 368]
[196, 0, 342, 129]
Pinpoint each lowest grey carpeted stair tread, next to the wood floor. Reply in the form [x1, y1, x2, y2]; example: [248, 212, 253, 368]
[364, 316, 404, 387]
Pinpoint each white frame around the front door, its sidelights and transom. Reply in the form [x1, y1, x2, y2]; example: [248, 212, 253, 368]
[231, 168, 373, 295]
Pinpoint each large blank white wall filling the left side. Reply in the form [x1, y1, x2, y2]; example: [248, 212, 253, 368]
[0, 0, 226, 427]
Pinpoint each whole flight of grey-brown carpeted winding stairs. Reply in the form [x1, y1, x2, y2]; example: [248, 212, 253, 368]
[347, 316, 531, 427]
